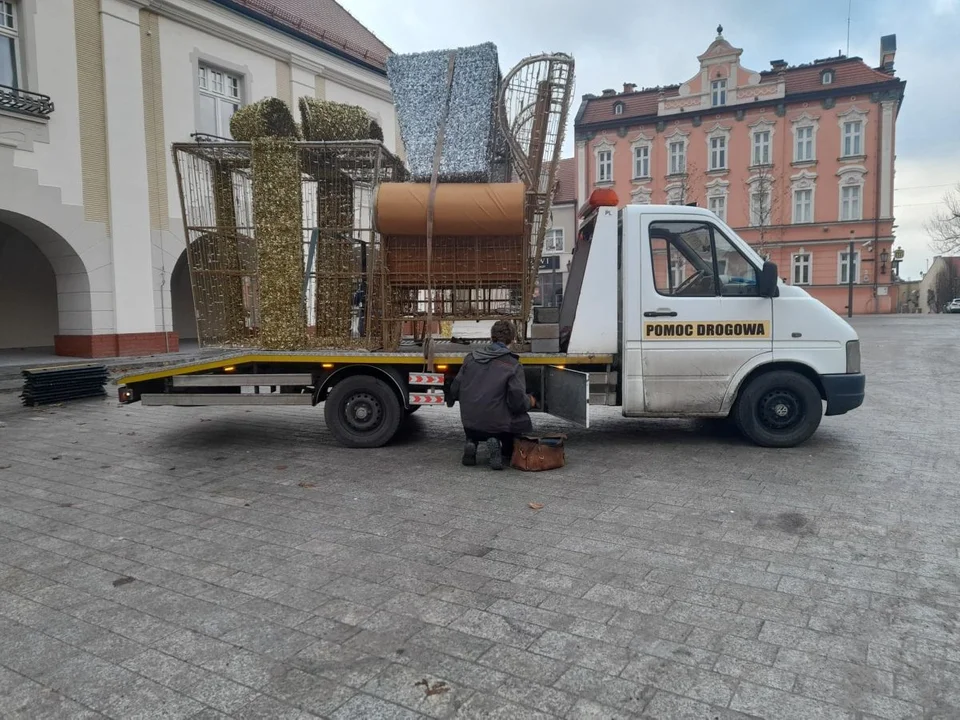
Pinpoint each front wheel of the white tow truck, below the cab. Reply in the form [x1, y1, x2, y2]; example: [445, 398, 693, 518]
[731, 370, 823, 448]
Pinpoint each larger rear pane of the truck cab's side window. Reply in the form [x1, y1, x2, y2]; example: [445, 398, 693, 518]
[650, 222, 717, 297]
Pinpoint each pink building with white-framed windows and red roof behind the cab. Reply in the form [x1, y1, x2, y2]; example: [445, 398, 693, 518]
[575, 28, 906, 314]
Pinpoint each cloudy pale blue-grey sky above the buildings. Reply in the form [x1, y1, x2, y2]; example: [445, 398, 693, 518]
[339, 0, 960, 277]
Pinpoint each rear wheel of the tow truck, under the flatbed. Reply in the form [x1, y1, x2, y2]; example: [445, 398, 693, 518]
[323, 375, 404, 448]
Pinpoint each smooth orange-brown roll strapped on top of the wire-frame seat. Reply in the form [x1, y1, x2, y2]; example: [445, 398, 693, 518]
[374, 183, 526, 237]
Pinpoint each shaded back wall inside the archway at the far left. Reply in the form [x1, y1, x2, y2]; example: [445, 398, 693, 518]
[0, 225, 57, 348]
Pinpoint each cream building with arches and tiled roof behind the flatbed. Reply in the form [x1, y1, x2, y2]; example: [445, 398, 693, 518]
[0, 0, 402, 357]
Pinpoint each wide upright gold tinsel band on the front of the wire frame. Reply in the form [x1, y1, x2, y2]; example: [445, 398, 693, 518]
[251, 137, 306, 350]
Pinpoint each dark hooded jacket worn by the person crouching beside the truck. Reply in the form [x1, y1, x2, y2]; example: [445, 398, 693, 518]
[450, 343, 533, 434]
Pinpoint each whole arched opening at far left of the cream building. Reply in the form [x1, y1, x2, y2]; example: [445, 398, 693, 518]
[0, 210, 92, 353]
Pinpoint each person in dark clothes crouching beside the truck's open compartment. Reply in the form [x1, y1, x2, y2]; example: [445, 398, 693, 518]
[449, 320, 536, 470]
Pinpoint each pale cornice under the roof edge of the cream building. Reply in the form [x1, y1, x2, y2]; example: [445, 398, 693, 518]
[145, 0, 393, 103]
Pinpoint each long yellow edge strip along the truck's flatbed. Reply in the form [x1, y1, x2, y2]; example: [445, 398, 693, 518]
[117, 353, 613, 385]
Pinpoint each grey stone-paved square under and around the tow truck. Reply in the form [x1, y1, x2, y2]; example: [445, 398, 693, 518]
[0, 316, 960, 720]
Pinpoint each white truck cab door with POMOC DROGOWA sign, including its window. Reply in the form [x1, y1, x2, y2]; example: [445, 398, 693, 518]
[640, 214, 773, 415]
